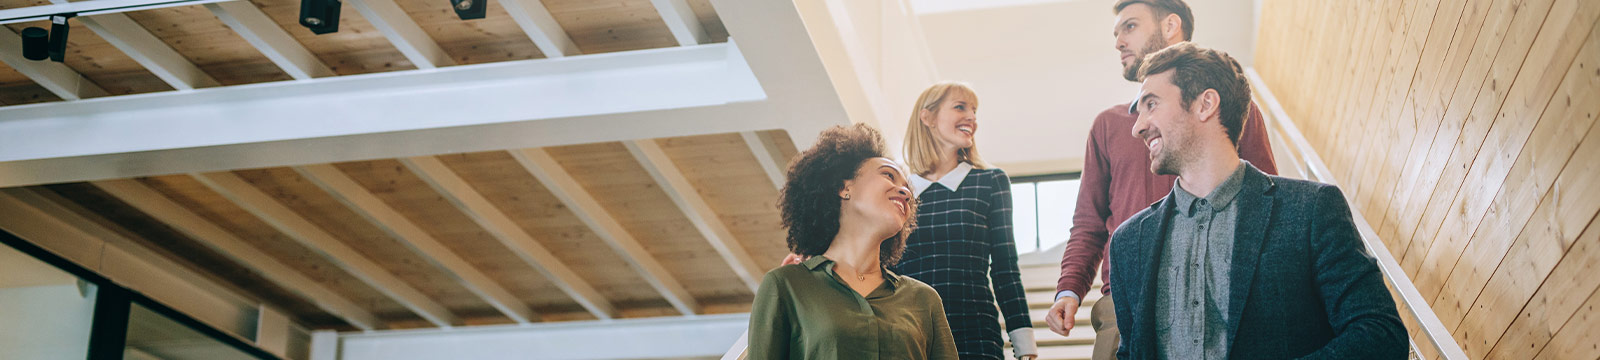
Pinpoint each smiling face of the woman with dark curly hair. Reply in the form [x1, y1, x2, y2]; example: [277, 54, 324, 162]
[840, 157, 914, 237]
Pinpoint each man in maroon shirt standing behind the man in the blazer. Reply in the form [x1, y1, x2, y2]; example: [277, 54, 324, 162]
[1045, 0, 1278, 360]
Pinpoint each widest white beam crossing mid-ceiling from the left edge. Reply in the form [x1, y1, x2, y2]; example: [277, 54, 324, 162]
[0, 43, 758, 178]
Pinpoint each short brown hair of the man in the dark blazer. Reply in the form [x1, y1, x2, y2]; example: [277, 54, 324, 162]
[1139, 42, 1250, 146]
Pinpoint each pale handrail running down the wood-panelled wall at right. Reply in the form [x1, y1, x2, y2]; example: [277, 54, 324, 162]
[1245, 67, 1467, 360]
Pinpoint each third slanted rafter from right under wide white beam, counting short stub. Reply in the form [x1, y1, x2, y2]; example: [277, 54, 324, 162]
[510, 149, 699, 315]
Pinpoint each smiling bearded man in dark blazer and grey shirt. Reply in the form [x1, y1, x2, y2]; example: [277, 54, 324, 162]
[1110, 43, 1408, 358]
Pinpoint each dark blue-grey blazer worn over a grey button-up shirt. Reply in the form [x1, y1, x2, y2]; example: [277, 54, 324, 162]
[1110, 166, 1410, 358]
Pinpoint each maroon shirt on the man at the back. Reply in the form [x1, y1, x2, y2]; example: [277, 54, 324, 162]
[1056, 102, 1278, 299]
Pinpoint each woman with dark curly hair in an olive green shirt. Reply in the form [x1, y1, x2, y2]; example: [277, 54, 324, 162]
[747, 125, 957, 360]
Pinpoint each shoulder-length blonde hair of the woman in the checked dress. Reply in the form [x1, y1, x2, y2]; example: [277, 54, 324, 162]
[906, 82, 989, 176]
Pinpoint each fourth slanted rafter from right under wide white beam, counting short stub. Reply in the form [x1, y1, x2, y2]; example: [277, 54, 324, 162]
[400, 157, 618, 320]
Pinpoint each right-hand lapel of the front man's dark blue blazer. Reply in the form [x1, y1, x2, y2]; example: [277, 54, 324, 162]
[1227, 165, 1277, 344]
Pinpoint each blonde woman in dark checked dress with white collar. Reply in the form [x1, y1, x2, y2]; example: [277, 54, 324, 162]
[891, 82, 1038, 360]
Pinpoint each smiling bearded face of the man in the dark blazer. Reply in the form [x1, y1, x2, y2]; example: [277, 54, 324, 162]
[1133, 70, 1198, 174]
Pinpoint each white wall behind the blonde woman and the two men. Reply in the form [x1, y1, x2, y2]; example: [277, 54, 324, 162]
[915, 0, 1256, 174]
